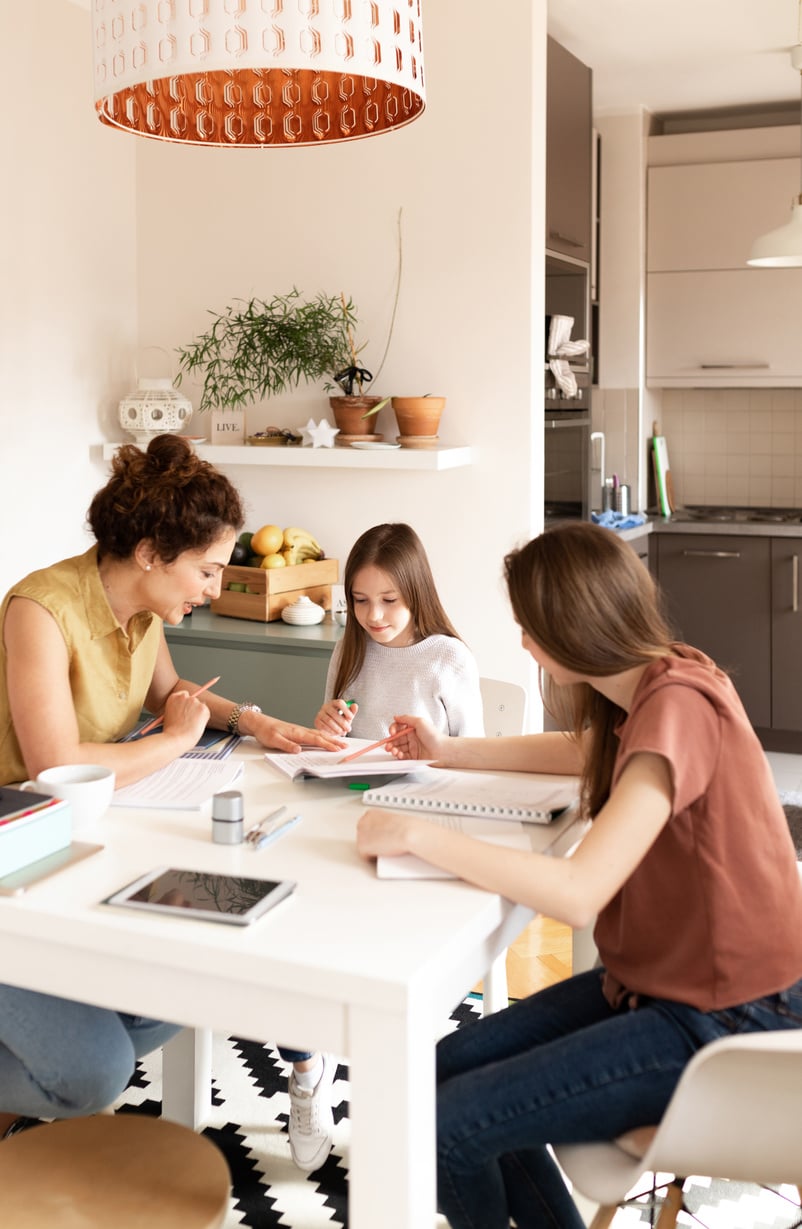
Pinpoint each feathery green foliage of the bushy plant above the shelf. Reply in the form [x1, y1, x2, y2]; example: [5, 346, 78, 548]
[176, 288, 365, 437]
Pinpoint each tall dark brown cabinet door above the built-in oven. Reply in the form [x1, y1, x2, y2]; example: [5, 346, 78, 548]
[545, 38, 593, 265]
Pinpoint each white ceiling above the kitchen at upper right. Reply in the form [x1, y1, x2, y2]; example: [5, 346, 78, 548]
[548, 0, 802, 114]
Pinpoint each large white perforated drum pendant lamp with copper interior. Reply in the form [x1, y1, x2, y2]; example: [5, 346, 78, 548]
[92, 0, 426, 147]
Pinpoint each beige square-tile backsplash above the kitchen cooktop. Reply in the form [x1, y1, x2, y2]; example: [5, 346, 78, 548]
[660, 388, 802, 508]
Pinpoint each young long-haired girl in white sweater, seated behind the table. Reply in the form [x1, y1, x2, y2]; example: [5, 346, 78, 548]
[314, 524, 484, 739]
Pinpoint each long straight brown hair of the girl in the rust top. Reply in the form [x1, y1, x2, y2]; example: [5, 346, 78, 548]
[505, 521, 672, 815]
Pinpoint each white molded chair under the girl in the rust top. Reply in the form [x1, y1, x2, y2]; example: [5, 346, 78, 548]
[554, 1029, 802, 1229]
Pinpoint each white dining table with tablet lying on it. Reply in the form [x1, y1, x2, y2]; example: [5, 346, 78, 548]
[0, 740, 580, 1229]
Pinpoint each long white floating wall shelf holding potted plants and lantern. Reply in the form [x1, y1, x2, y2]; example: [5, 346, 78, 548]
[103, 440, 475, 469]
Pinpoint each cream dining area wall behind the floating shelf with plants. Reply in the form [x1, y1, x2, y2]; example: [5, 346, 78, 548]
[0, 0, 545, 708]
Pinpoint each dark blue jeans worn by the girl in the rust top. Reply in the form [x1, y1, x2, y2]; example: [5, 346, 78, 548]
[437, 968, 802, 1229]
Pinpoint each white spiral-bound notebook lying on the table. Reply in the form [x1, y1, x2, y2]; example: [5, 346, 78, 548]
[361, 768, 578, 823]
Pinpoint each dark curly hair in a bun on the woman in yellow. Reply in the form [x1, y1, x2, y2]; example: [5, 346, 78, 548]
[87, 435, 244, 563]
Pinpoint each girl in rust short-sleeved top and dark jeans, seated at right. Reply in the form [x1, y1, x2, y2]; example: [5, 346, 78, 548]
[357, 522, 802, 1229]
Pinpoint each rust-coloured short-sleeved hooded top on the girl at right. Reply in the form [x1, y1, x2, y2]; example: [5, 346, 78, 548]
[594, 645, 802, 1011]
